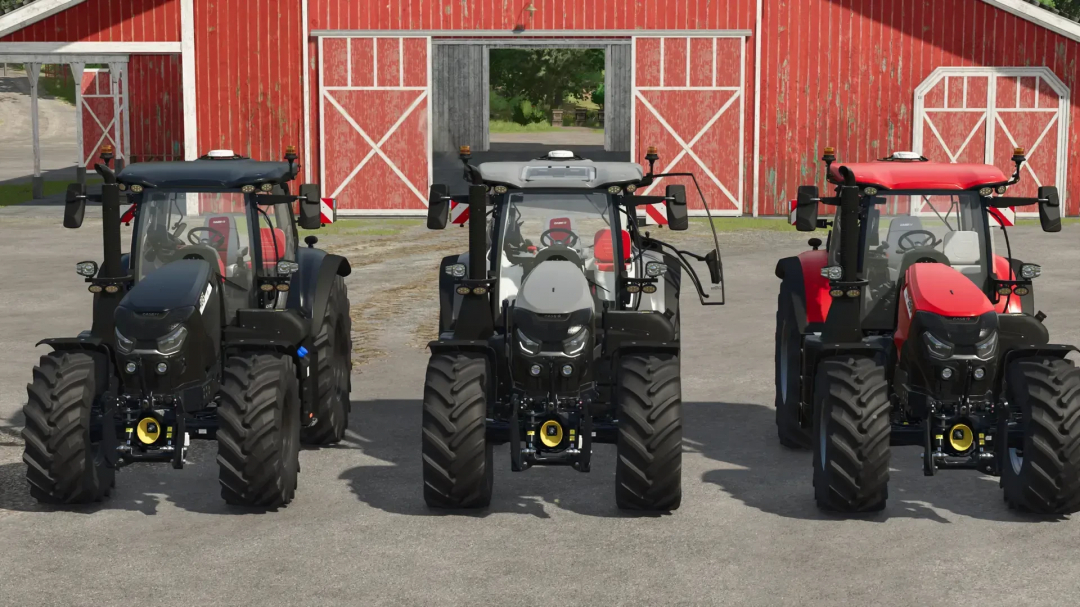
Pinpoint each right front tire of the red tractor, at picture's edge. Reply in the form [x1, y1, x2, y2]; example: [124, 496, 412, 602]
[999, 359, 1080, 514]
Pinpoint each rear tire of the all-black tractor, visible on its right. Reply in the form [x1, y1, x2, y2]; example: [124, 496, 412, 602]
[300, 276, 352, 445]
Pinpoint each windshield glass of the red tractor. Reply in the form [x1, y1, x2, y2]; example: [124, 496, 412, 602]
[829, 192, 989, 329]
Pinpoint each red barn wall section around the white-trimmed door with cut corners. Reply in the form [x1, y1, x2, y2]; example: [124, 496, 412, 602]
[760, 0, 1080, 215]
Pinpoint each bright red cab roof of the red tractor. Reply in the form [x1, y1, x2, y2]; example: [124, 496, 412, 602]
[828, 160, 1009, 190]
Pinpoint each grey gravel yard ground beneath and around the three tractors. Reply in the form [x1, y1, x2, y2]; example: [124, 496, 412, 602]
[0, 207, 1080, 607]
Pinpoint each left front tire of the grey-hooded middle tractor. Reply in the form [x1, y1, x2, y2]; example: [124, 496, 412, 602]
[421, 353, 495, 510]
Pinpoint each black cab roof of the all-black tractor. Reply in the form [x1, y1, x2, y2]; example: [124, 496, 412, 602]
[117, 158, 297, 189]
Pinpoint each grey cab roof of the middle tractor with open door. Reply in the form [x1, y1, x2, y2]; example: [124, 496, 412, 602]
[476, 158, 645, 190]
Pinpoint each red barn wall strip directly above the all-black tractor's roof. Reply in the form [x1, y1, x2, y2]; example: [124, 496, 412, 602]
[194, 0, 303, 160]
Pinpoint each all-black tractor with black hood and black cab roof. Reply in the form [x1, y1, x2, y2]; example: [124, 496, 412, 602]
[23, 147, 352, 508]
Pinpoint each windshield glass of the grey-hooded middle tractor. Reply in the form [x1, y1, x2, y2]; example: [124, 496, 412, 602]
[499, 191, 631, 301]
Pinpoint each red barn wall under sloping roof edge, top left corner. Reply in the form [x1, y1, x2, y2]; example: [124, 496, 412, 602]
[0, 0, 180, 42]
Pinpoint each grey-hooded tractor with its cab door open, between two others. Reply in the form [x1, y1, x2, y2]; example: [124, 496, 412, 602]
[422, 147, 724, 511]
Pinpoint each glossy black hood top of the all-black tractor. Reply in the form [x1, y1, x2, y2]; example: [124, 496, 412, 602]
[120, 259, 211, 314]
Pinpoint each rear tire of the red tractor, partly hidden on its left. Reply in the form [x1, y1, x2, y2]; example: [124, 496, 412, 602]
[774, 283, 812, 449]
